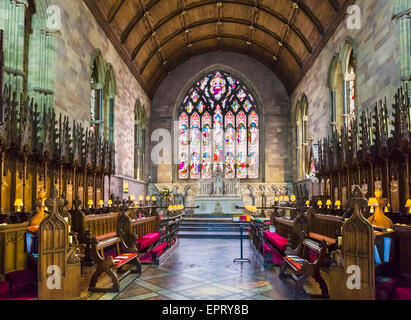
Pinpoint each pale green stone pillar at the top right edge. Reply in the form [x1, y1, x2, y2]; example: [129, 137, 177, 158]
[393, 0, 411, 83]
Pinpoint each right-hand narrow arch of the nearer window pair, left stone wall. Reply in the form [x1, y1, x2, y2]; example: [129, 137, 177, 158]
[103, 64, 117, 142]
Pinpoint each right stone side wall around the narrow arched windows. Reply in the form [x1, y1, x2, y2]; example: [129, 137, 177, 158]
[291, 0, 400, 181]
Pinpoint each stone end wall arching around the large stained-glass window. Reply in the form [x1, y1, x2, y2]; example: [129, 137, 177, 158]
[150, 51, 292, 183]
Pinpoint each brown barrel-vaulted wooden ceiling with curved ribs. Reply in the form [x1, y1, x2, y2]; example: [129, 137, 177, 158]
[84, 0, 354, 97]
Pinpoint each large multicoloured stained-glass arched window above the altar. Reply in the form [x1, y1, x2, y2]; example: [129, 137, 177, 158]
[178, 71, 260, 179]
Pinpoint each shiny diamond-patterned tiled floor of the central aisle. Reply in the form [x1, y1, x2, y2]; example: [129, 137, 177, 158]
[88, 239, 308, 300]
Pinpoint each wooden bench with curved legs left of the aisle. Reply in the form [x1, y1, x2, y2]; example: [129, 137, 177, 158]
[89, 234, 141, 292]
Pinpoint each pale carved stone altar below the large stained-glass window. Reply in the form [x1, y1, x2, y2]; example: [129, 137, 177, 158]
[194, 169, 243, 214]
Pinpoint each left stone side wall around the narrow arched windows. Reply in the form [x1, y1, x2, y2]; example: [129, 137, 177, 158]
[53, 0, 150, 195]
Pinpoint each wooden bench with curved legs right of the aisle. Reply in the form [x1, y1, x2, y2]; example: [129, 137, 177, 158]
[280, 231, 329, 299]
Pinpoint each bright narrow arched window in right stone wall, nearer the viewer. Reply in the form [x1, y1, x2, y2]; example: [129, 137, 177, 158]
[340, 39, 357, 128]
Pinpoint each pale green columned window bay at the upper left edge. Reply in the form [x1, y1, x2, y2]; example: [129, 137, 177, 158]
[0, 0, 60, 104]
